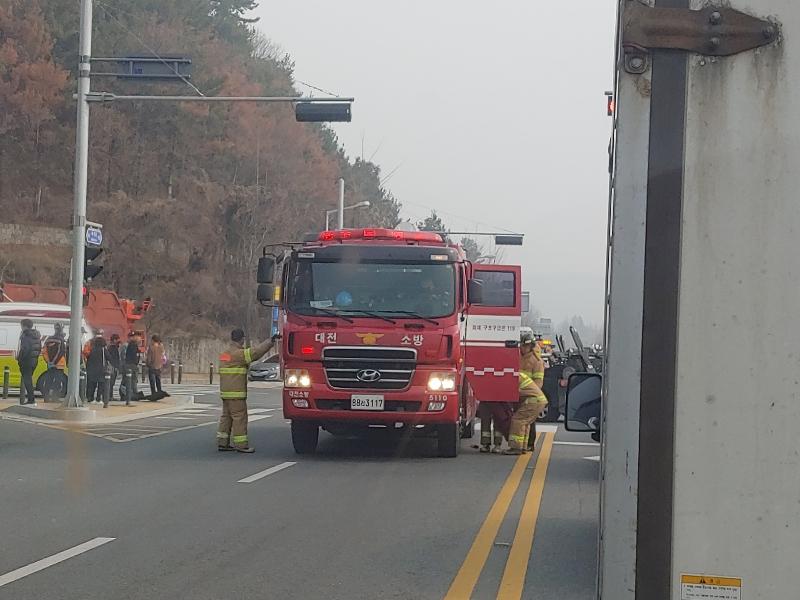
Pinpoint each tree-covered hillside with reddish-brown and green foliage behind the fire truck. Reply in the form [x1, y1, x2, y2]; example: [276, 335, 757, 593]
[0, 0, 399, 336]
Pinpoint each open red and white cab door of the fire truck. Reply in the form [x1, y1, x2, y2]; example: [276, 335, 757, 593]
[462, 264, 522, 402]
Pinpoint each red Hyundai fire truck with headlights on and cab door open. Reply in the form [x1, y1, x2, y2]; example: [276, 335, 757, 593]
[253, 229, 521, 457]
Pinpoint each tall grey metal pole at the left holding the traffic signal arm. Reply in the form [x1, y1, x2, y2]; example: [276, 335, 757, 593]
[65, 0, 92, 408]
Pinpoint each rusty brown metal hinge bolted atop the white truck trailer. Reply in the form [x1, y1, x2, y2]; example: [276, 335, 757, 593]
[622, 0, 779, 73]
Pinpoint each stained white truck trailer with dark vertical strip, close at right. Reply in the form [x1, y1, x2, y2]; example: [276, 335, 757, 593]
[570, 0, 800, 600]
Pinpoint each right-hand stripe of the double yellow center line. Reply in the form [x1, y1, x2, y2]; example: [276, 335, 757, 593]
[497, 432, 555, 600]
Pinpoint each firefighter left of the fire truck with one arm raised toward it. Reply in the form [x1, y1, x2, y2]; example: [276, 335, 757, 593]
[217, 329, 277, 454]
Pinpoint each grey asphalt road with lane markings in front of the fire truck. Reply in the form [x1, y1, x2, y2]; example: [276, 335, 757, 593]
[0, 390, 599, 600]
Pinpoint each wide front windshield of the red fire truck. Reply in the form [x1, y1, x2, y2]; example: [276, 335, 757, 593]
[287, 261, 456, 319]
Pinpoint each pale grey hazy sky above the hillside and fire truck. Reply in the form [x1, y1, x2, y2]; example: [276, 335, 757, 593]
[255, 0, 616, 323]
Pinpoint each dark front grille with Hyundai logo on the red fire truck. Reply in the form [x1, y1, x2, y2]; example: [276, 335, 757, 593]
[322, 346, 417, 390]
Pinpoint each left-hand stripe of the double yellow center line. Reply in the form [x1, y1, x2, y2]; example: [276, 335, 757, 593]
[444, 454, 532, 600]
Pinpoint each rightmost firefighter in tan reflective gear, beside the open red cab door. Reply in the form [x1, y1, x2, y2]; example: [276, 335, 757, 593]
[503, 334, 547, 455]
